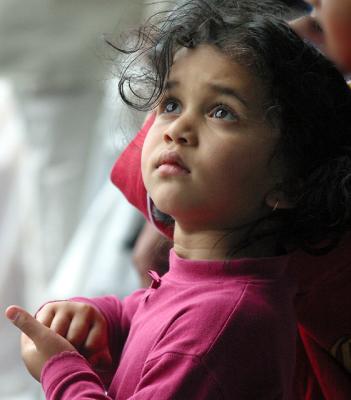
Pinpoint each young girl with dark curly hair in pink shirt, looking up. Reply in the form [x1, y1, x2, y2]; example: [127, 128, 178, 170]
[7, 0, 351, 400]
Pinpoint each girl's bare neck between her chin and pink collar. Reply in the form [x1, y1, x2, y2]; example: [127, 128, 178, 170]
[174, 224, 277, 260]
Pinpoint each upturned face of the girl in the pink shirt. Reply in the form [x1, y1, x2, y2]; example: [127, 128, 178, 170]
[142, 45, 280, 231]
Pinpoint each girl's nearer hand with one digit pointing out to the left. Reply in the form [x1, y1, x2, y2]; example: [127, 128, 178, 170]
[6, 306, 76, 381]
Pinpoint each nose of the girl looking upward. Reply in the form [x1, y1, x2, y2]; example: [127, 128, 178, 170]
[163, 117, 197, 146]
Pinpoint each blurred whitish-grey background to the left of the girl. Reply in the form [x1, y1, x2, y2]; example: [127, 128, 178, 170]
[0, 0, 157, 400]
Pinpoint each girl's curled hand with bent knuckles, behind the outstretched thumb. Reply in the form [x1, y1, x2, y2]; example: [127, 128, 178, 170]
[36, 301, 112, 369]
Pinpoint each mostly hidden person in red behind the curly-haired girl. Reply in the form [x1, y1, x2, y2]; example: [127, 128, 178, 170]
[117, 0, 351, 399]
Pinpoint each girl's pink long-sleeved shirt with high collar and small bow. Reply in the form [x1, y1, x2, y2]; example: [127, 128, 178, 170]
[42, 250, 296, 400]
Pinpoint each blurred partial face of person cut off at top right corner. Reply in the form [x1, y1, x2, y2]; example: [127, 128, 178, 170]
[306, 0, 351, 71]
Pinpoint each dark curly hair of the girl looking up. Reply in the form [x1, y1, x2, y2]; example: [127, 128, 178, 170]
[110, 0, 351, 254]
